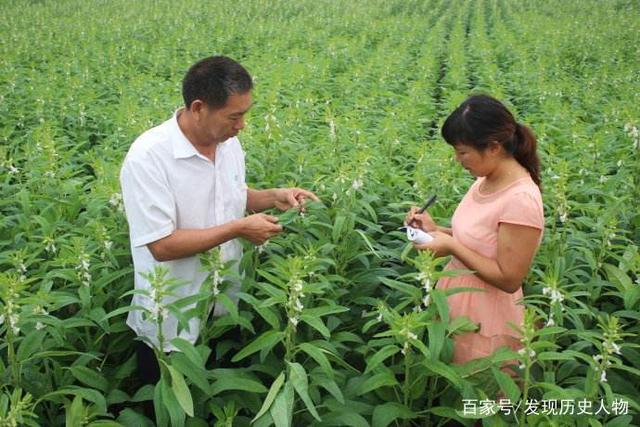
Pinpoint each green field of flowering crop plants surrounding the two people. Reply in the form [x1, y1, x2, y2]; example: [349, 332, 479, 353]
[0, 0, 640, 427]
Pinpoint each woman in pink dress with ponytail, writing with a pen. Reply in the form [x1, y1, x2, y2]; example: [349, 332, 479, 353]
[406, 95, 544, 363]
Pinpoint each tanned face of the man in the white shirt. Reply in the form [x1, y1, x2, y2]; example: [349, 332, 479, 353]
[200, 92, 251, 143]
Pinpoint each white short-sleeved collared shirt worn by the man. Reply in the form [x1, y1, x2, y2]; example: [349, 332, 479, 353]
[120, 110, 247, 351]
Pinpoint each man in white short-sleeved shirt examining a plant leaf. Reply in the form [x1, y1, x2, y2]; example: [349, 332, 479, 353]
[120, 56, 317, 357]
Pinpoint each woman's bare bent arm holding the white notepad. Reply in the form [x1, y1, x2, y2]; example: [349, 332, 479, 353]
[416, 223, 542, 293]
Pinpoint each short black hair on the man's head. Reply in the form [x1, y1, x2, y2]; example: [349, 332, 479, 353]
[182, 56, 253, 108]
